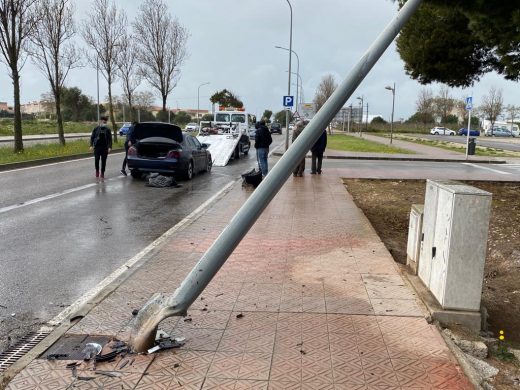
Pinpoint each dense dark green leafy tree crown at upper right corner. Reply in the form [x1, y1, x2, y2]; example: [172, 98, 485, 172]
[397, 0, 520, 87]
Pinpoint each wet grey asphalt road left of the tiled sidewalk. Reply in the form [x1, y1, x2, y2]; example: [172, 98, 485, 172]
[0, 137, 283, 351]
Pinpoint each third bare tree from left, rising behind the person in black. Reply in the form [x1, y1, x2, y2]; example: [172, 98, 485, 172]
[82, 0, 127, 142]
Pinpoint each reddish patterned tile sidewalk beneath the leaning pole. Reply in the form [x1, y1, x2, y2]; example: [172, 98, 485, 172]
[8, 170, 472, 390]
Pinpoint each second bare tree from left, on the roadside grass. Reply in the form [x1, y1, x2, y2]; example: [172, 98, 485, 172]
[31, 0, 79, 145]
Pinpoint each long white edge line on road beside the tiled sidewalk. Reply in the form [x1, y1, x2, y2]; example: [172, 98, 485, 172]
[47, 180, 236, 326]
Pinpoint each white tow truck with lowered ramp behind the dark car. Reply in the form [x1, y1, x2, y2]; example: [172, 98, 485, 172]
[197, 107, 256, 167]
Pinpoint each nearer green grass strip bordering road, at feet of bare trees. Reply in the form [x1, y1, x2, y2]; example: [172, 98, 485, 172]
[0, 140, 123, 164]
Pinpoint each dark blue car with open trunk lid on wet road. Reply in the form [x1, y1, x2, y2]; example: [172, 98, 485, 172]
[128, 122, 212, 180]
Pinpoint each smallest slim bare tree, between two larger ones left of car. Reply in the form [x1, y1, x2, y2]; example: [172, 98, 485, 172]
[117, 36, 141, 122]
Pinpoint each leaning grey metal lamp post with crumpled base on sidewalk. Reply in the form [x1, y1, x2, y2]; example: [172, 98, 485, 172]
[130, 0, 421, 352]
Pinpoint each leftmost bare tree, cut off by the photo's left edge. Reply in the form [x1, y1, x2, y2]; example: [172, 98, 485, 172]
[0, 0, 36, 153]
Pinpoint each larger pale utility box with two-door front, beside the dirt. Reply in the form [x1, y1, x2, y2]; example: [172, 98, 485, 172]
[418, 180, 491, 311]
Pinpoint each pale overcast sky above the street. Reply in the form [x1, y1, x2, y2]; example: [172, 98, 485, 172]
[0, 0, 520, 120]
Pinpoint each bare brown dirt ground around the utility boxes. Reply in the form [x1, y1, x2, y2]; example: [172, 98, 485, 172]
[344, 179, 520, 347]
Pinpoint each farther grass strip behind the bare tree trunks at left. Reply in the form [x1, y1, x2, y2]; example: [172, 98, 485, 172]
[0, 119, 96, 136]
